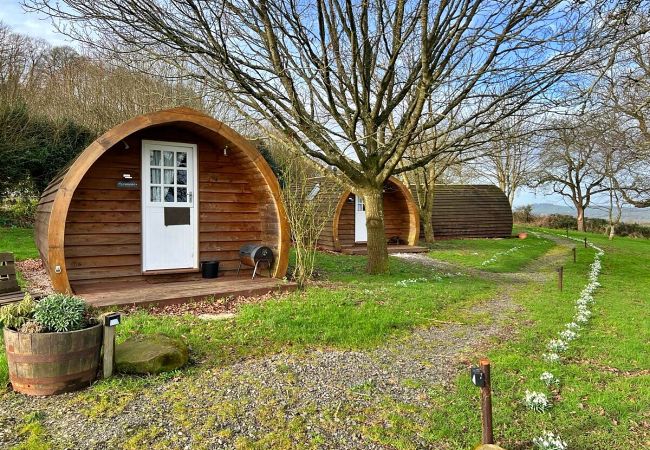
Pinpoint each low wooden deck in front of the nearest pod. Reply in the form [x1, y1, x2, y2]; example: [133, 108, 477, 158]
[75, 277, 296, 307]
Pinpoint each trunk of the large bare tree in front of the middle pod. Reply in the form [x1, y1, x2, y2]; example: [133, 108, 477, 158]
[361, 187, 388, 274]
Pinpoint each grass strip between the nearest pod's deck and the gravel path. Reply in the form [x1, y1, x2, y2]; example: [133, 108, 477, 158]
[118, 253, 496, 362]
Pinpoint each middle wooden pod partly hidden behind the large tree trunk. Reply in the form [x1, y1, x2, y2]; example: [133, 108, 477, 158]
[312, 177, 426, 254]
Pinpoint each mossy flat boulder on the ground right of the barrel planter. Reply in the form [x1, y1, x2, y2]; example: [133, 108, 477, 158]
[115, 334, 189, 374]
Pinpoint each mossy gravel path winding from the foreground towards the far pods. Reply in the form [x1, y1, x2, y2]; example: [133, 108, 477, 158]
[0, 239, 566, 449]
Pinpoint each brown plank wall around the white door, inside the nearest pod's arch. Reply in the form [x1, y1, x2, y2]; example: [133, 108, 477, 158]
[65, 127, 270, 290]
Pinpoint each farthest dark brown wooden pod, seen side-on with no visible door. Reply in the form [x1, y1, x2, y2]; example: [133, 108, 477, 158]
[431, 184, 512, 239]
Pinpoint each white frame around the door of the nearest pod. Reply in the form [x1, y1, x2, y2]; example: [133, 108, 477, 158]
[140, 139, 199, 273]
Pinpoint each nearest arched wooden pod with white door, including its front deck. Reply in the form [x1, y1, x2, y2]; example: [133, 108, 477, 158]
[35, 108, 289, 306]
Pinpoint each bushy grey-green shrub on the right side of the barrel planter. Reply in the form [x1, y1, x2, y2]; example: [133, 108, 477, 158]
[34, 294, 88, 332]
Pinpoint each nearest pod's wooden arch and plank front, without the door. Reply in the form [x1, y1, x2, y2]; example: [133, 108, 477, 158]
[36, 108, 289, 292]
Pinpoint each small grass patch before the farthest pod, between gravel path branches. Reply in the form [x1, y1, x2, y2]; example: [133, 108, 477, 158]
[429, 230, 553, 272]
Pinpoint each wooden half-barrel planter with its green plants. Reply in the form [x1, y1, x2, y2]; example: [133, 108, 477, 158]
[0, 294, 102, 395]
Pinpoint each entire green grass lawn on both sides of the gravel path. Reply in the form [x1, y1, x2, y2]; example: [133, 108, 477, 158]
[0, 230, 650, 450]
